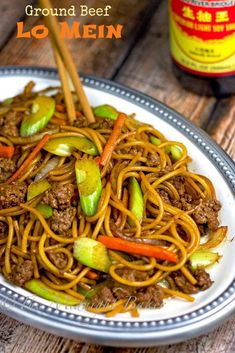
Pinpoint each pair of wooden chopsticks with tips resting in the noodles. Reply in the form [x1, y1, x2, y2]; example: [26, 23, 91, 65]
[39, 0, 95, 125]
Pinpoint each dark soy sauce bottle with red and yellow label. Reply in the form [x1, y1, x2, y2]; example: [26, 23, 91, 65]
[169, 0, 235, 97]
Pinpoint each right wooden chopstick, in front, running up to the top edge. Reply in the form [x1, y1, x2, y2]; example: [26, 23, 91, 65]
[39, 0, 95, 123]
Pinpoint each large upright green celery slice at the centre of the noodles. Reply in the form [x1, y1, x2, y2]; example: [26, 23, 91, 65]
[75, 159, 102, 216]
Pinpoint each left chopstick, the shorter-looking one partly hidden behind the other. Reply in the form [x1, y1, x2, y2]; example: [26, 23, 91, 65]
[52, 45, 76, 125]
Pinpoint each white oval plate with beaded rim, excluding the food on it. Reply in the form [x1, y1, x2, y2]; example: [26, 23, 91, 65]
[0, 67, 235, 346]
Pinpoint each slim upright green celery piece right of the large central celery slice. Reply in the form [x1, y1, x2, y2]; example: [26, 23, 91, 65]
[128, 177, 144, 225]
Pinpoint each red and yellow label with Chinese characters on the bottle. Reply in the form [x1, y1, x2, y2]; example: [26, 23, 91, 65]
[169, 0, 235, 76]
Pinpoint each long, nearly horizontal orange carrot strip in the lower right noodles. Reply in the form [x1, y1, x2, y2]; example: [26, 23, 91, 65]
[98, 235, 177, 263]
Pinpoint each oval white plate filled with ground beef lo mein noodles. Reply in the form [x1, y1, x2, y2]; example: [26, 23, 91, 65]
[0, 67, 235, 346]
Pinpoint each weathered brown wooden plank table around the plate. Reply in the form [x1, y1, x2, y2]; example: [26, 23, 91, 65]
[0, 0, 235, 353]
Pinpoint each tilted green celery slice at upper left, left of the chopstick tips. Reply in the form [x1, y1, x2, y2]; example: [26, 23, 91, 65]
[20, 96, 55, 137]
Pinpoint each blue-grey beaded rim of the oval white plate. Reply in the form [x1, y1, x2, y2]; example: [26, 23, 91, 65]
[0, 66, 235, 346]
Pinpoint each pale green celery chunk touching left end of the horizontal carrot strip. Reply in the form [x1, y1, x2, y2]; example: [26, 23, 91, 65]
[73, 238, 111, 273]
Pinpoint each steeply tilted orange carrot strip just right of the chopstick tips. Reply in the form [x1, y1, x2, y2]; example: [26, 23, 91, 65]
[100, 113, 127, 166]
